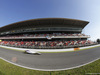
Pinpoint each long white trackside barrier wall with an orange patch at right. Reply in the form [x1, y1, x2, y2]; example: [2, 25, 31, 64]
[0, 44, 100, 52]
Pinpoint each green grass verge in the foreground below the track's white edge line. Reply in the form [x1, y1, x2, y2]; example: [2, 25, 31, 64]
[0, 59, 100, 75]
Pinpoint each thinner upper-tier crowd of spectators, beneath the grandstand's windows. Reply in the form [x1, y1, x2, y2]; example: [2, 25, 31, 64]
[0, 33, 86, 39]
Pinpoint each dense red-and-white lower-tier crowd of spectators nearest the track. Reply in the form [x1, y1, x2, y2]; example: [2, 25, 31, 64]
[0, 40, 96, 48]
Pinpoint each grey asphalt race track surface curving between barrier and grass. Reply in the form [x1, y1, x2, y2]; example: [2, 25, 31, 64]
[0, 47, 100, 71]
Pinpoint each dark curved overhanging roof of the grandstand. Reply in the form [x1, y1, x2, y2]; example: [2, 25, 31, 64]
[0, 18, 89, 32]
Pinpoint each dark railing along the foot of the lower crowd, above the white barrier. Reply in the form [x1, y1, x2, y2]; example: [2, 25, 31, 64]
[1, 43, 97, 49]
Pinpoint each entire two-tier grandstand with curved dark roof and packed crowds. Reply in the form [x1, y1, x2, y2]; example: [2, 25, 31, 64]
[0, 18, 96, 49]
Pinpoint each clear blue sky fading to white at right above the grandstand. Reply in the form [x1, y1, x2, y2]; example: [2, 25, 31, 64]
[0, 0, 100, 40]
